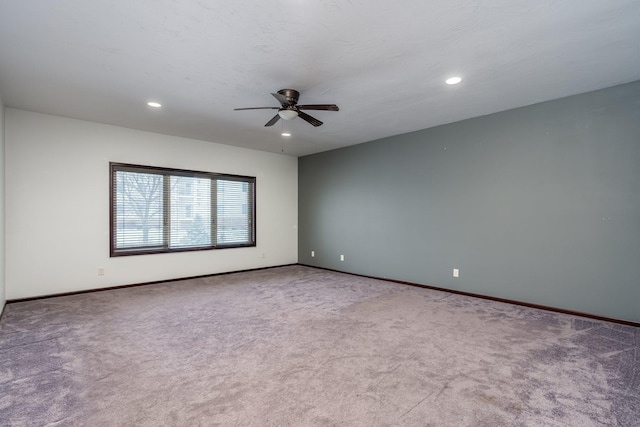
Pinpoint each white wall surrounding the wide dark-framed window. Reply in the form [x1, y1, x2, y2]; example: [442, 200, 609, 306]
[5, 108, 298, 300]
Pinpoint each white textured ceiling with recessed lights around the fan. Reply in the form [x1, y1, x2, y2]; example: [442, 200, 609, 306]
[0, 0, 640, 156]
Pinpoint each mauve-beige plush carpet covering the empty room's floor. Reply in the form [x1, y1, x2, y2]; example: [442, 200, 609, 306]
[0, 266, 640, 427]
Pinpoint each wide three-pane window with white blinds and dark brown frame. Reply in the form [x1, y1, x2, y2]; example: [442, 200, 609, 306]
[110, 163, 256, 256]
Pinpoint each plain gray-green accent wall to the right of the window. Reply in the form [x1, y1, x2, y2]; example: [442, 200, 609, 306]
[298, 82, 640, 322]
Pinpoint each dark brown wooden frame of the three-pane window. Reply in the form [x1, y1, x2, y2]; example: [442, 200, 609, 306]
[109, 162, 257, 257]
